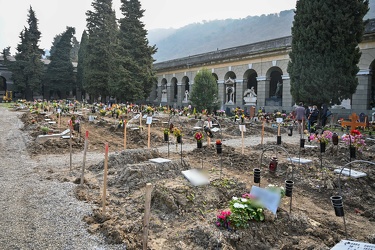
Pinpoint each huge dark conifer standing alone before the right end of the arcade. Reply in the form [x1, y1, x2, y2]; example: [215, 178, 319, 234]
[288, 0, 368, 106]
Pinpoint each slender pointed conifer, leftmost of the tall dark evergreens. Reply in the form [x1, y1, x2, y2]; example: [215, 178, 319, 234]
[8, 6, 44, 100]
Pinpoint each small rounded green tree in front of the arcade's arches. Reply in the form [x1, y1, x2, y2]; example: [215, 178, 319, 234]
[190, 69, 218, 112]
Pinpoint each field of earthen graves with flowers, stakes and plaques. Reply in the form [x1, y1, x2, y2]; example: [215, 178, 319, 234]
[8, 100, 375, 249]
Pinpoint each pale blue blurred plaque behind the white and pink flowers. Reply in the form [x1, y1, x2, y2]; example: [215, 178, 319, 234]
[250, 186, 281, 214]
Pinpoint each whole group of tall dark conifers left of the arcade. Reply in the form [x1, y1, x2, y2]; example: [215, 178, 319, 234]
[3, 0, 156, 101]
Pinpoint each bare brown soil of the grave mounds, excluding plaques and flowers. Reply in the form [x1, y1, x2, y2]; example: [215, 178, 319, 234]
[22, 110, 375, 249]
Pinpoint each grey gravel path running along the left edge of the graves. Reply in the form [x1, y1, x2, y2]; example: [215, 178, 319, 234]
[0, 107, 125, 250]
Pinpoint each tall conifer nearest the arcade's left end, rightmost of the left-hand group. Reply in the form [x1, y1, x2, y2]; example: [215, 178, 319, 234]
[111, 0, 156, 101]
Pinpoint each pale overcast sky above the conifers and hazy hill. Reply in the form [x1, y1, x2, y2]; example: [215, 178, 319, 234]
[0, 0, 297, 54]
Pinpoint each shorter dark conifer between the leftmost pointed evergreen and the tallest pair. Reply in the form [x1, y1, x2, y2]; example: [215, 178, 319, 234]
[44, 27, 75, 99]
